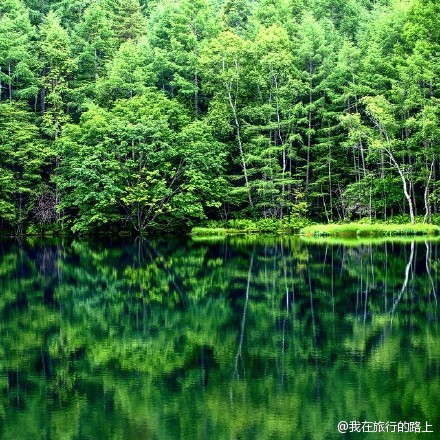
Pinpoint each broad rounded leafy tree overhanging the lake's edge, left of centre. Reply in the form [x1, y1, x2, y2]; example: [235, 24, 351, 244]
[55, 91, 225, 233]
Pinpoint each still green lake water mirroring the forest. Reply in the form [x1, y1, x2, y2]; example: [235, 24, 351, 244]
[0, 237, 440, 440]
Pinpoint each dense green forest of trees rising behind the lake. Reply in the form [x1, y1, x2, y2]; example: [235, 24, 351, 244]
[0, 0, 440, 234]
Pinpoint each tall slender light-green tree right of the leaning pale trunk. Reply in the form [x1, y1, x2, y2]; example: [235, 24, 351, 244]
[243, 25, 304, 218]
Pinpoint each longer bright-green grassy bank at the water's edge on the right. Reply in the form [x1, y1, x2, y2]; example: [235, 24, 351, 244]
[300, 223, 440, 237]
